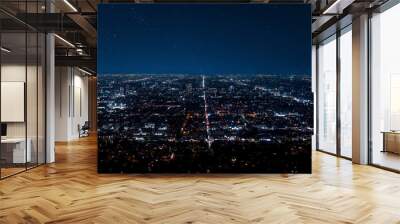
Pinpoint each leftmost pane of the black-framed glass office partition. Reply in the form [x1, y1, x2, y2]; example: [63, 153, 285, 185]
[0, 32, 27, 177]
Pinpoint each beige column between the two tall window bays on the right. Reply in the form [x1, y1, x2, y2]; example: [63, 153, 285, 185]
[352, 15, 368, 164]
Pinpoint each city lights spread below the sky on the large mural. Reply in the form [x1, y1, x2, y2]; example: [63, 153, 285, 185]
[98, 74, 313, 173]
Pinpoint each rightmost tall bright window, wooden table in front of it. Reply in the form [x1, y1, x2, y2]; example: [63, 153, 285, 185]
[370, 4, 400, 170]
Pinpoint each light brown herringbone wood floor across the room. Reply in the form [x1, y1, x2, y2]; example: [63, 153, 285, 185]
[0, 137, 400, 224]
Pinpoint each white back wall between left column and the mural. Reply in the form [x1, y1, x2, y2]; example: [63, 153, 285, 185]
[55, 67, 89, 141]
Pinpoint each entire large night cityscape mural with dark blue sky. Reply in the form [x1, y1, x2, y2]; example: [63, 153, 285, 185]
[97, 4, 313, 173]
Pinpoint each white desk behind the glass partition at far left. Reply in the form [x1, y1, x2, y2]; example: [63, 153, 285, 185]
[1, 138, 32, 164]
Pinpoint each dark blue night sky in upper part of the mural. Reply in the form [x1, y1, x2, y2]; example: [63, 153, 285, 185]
[98, 4, 311, 75]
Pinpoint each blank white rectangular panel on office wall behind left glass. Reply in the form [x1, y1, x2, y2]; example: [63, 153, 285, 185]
[1, 82, 25, 122]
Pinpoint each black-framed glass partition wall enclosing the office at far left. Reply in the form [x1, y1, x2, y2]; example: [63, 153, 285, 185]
[0, 1, 46, 178]
